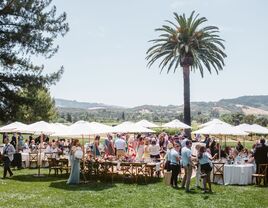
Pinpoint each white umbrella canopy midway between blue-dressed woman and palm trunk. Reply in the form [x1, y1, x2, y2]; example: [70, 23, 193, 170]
[113, 121, 154, 133]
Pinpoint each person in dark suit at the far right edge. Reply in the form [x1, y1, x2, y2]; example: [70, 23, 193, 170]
[254, 139, 268, 180]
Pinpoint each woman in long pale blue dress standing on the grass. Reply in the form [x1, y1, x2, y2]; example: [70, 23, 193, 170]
[67, 139, 82, 184]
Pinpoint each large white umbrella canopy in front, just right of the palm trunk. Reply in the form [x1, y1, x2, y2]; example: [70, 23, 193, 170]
[193, 123, 248, 136]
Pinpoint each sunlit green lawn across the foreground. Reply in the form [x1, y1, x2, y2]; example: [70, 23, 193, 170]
[0, 167, 268, 208]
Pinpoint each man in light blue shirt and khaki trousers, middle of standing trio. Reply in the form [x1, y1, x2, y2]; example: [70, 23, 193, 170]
[181, 140, 193, 192]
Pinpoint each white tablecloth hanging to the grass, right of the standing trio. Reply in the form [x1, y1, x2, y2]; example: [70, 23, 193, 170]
[224, 164, 254, 185]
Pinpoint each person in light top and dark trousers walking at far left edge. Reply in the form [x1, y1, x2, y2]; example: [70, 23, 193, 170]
[3, 137, 15, 179]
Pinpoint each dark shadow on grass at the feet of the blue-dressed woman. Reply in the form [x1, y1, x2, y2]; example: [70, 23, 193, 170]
[49, 181, 116, 191]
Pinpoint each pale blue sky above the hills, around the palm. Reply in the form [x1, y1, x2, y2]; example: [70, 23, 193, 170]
[38, 0, 268, 107]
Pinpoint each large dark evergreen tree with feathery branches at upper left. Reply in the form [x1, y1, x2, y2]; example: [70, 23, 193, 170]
[0, 0, 69, 121]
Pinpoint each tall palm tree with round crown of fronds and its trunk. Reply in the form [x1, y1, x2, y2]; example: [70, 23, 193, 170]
[146, 11, 226, 136]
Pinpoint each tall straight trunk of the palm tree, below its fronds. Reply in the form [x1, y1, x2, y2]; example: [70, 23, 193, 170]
[183, 65, 191, 138]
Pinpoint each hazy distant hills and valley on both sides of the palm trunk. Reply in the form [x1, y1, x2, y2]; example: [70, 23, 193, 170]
[55, 95, 268, 121]
